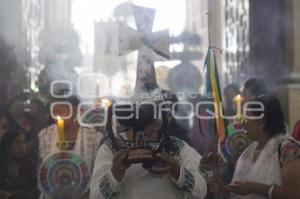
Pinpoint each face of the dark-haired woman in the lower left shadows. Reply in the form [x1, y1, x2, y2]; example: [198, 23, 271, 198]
[9, 134, 26, 159]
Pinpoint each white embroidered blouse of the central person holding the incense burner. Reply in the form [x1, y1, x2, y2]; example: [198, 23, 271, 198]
[90, 138, 207, 199]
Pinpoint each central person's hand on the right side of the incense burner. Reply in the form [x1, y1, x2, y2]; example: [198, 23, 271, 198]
[148, 153, 180, 180]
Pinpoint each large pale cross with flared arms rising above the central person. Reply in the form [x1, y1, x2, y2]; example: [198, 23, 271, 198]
[119, 6, 169, 89]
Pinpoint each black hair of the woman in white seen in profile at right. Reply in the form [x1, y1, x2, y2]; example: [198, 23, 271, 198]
[249, 95, 286, 137]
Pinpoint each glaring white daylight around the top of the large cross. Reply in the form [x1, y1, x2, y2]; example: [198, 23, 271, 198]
[72, 0, 186, 54]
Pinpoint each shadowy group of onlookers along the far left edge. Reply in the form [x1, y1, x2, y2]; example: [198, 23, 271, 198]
[0, 96, 51, 199]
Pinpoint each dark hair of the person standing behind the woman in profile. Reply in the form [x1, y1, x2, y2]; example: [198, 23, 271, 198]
[244, 77, 268, 97]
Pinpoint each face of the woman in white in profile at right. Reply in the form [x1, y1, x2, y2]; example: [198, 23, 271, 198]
[243, 113, 264, 141]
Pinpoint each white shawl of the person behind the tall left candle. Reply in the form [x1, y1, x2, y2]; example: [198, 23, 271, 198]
[39, 124, 103, 199]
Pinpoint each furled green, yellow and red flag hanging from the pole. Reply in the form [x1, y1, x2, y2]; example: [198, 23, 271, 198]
[204, 48, 228, 141]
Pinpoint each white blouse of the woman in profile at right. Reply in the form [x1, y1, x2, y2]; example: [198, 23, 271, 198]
[230, 134, 292, 199]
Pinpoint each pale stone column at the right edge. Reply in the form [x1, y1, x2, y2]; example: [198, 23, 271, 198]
[282, 0, 300, 131]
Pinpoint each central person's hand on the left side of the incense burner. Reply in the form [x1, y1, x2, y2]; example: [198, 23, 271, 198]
[111, 150, 130, 182]
